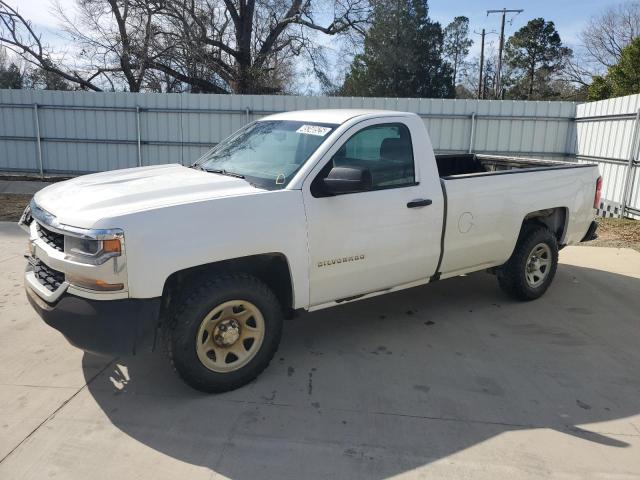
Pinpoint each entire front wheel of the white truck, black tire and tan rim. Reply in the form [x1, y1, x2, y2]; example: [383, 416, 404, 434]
[168, 275, 282, 393]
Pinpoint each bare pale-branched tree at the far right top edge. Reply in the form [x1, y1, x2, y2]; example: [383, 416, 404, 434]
[580, 1, 640, 70]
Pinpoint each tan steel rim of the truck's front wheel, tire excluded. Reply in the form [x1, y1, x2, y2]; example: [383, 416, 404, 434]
[196, 300, 264, 373]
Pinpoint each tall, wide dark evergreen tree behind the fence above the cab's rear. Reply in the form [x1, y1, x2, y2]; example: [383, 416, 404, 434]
[341, 0, 454, 98]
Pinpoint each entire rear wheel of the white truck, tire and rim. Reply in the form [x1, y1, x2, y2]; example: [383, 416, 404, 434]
[498, 226, 558, 300]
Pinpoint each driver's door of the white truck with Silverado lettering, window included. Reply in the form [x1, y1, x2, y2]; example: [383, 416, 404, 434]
[303, 117, 442, 307]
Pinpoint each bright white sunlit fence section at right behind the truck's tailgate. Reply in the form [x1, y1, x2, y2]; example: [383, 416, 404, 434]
[569, 95, 640, 218]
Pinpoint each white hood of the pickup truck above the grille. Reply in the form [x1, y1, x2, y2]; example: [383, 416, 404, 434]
[34, 164, 265, 228]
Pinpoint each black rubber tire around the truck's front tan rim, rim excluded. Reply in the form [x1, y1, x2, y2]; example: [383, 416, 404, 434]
[167, 274, 283, 393]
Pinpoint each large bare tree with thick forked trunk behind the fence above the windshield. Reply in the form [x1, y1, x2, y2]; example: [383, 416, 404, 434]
[153, 0, 369, 93]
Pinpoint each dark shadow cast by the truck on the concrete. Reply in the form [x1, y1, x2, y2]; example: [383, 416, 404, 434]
[83, 265, 640, 479]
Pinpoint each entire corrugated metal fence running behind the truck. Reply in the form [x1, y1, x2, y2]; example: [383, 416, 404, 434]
[0, 90, 640, 215]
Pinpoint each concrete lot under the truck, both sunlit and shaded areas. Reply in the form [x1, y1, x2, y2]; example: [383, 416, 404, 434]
[0, 223, 640, 480]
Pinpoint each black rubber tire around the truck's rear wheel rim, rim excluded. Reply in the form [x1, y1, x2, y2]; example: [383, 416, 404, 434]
[497, 225, 558, 301]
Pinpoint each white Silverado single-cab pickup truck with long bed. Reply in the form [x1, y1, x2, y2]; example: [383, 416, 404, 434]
[21, 110, 601, 392]
